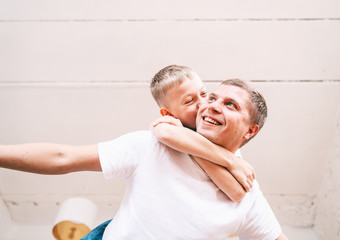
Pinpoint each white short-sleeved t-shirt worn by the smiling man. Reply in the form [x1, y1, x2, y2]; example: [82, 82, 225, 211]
[98, 131, 281, 240]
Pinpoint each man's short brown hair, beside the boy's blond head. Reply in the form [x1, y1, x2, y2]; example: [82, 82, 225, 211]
[222, 78, 268, 145]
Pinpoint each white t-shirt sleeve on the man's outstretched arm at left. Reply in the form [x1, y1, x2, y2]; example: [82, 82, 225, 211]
[98, 131, 151, 178]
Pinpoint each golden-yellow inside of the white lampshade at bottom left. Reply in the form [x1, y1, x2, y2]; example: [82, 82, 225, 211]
[53, 221, 91, 240]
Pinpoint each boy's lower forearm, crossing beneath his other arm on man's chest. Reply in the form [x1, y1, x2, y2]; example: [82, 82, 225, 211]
[194, 157, 246, 202]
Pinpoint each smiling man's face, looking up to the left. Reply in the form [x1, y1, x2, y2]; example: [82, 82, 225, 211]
[196, 85, 252, 152]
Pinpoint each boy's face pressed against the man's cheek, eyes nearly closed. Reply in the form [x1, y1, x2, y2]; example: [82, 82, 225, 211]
[166, 76, 207, 129]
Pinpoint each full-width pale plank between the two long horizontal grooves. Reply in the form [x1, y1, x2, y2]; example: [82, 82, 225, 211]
[0, 21, 340, 82]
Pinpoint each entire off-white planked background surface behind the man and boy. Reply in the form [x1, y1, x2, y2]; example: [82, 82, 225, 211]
[0, 0, 340, 239]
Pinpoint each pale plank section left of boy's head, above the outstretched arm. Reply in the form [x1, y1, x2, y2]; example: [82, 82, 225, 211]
[0, 84, 160, 145]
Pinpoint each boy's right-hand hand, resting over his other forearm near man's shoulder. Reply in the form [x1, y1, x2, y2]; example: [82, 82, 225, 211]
[228, 156, 255, 192]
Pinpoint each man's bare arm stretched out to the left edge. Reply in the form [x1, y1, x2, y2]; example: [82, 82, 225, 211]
[0, 143, 101, 174]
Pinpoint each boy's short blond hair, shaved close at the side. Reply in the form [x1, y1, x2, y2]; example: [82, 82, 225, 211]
[150, 65, 198, 107]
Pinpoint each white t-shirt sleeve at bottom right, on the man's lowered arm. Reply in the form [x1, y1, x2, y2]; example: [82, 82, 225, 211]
[239, 186, 282, 240]
